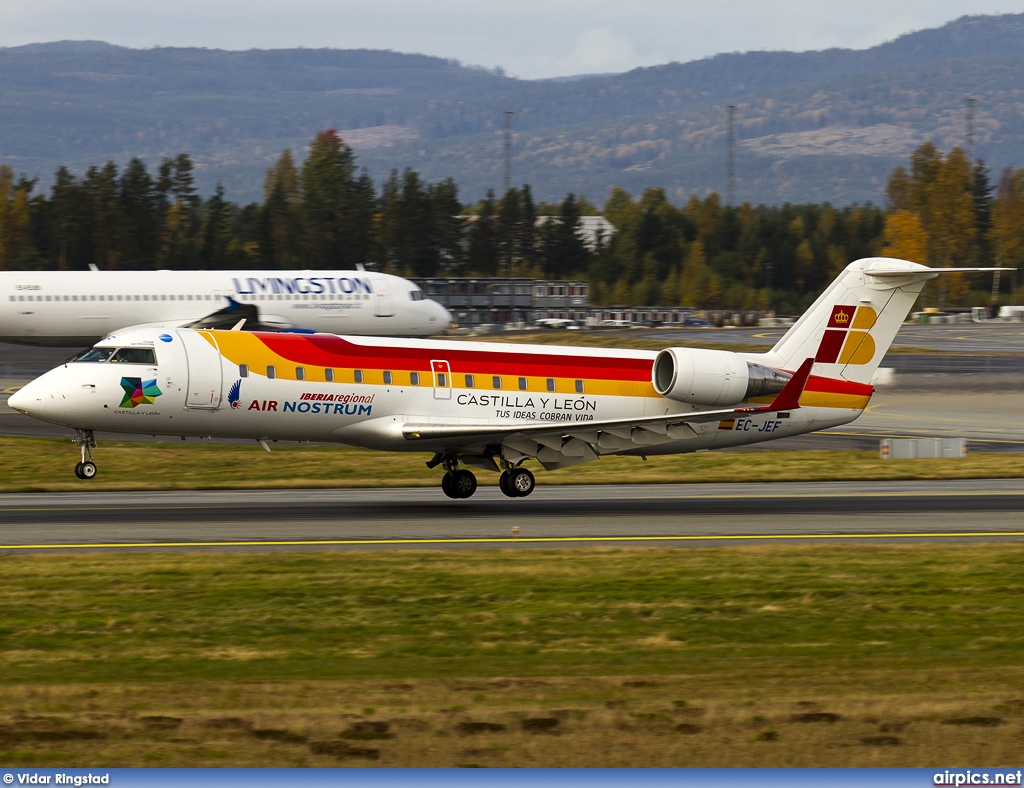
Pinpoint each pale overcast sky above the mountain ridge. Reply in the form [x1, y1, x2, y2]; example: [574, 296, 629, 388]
[6, 0, 1024, 79]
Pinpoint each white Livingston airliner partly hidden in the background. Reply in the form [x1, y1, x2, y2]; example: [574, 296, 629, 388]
[0, 270, 452, 347]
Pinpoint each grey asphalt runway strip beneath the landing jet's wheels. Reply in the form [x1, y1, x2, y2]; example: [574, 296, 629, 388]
[0, 479, 1024, 553]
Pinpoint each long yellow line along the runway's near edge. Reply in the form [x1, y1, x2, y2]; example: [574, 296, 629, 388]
[6, 531, 1024, 550]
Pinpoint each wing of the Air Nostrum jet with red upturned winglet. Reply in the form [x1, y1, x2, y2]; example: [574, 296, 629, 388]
[402, 358, 814, 471]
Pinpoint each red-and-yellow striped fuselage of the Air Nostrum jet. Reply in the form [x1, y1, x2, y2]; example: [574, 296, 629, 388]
[12, 329, 871, 454]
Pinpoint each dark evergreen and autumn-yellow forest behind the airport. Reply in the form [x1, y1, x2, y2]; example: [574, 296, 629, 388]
[0, 130, 1024, 313]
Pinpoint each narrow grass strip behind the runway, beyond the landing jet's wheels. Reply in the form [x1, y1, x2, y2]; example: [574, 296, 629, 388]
[0, 438, 1024, 492]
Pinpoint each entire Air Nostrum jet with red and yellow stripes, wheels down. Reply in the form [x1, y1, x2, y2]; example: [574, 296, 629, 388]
[8, 258, 991, 498]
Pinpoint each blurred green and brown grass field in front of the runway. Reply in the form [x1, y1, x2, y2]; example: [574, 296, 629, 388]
[0, 542, 1024, 767]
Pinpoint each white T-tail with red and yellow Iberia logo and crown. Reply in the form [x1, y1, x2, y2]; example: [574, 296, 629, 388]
[761, 257, 1005, 384]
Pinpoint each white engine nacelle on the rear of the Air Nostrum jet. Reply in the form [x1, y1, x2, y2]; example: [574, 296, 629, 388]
[652, 348, 793, 405]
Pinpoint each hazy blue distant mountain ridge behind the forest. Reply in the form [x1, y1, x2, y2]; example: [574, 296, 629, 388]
[0, 14, 1024, 203]
